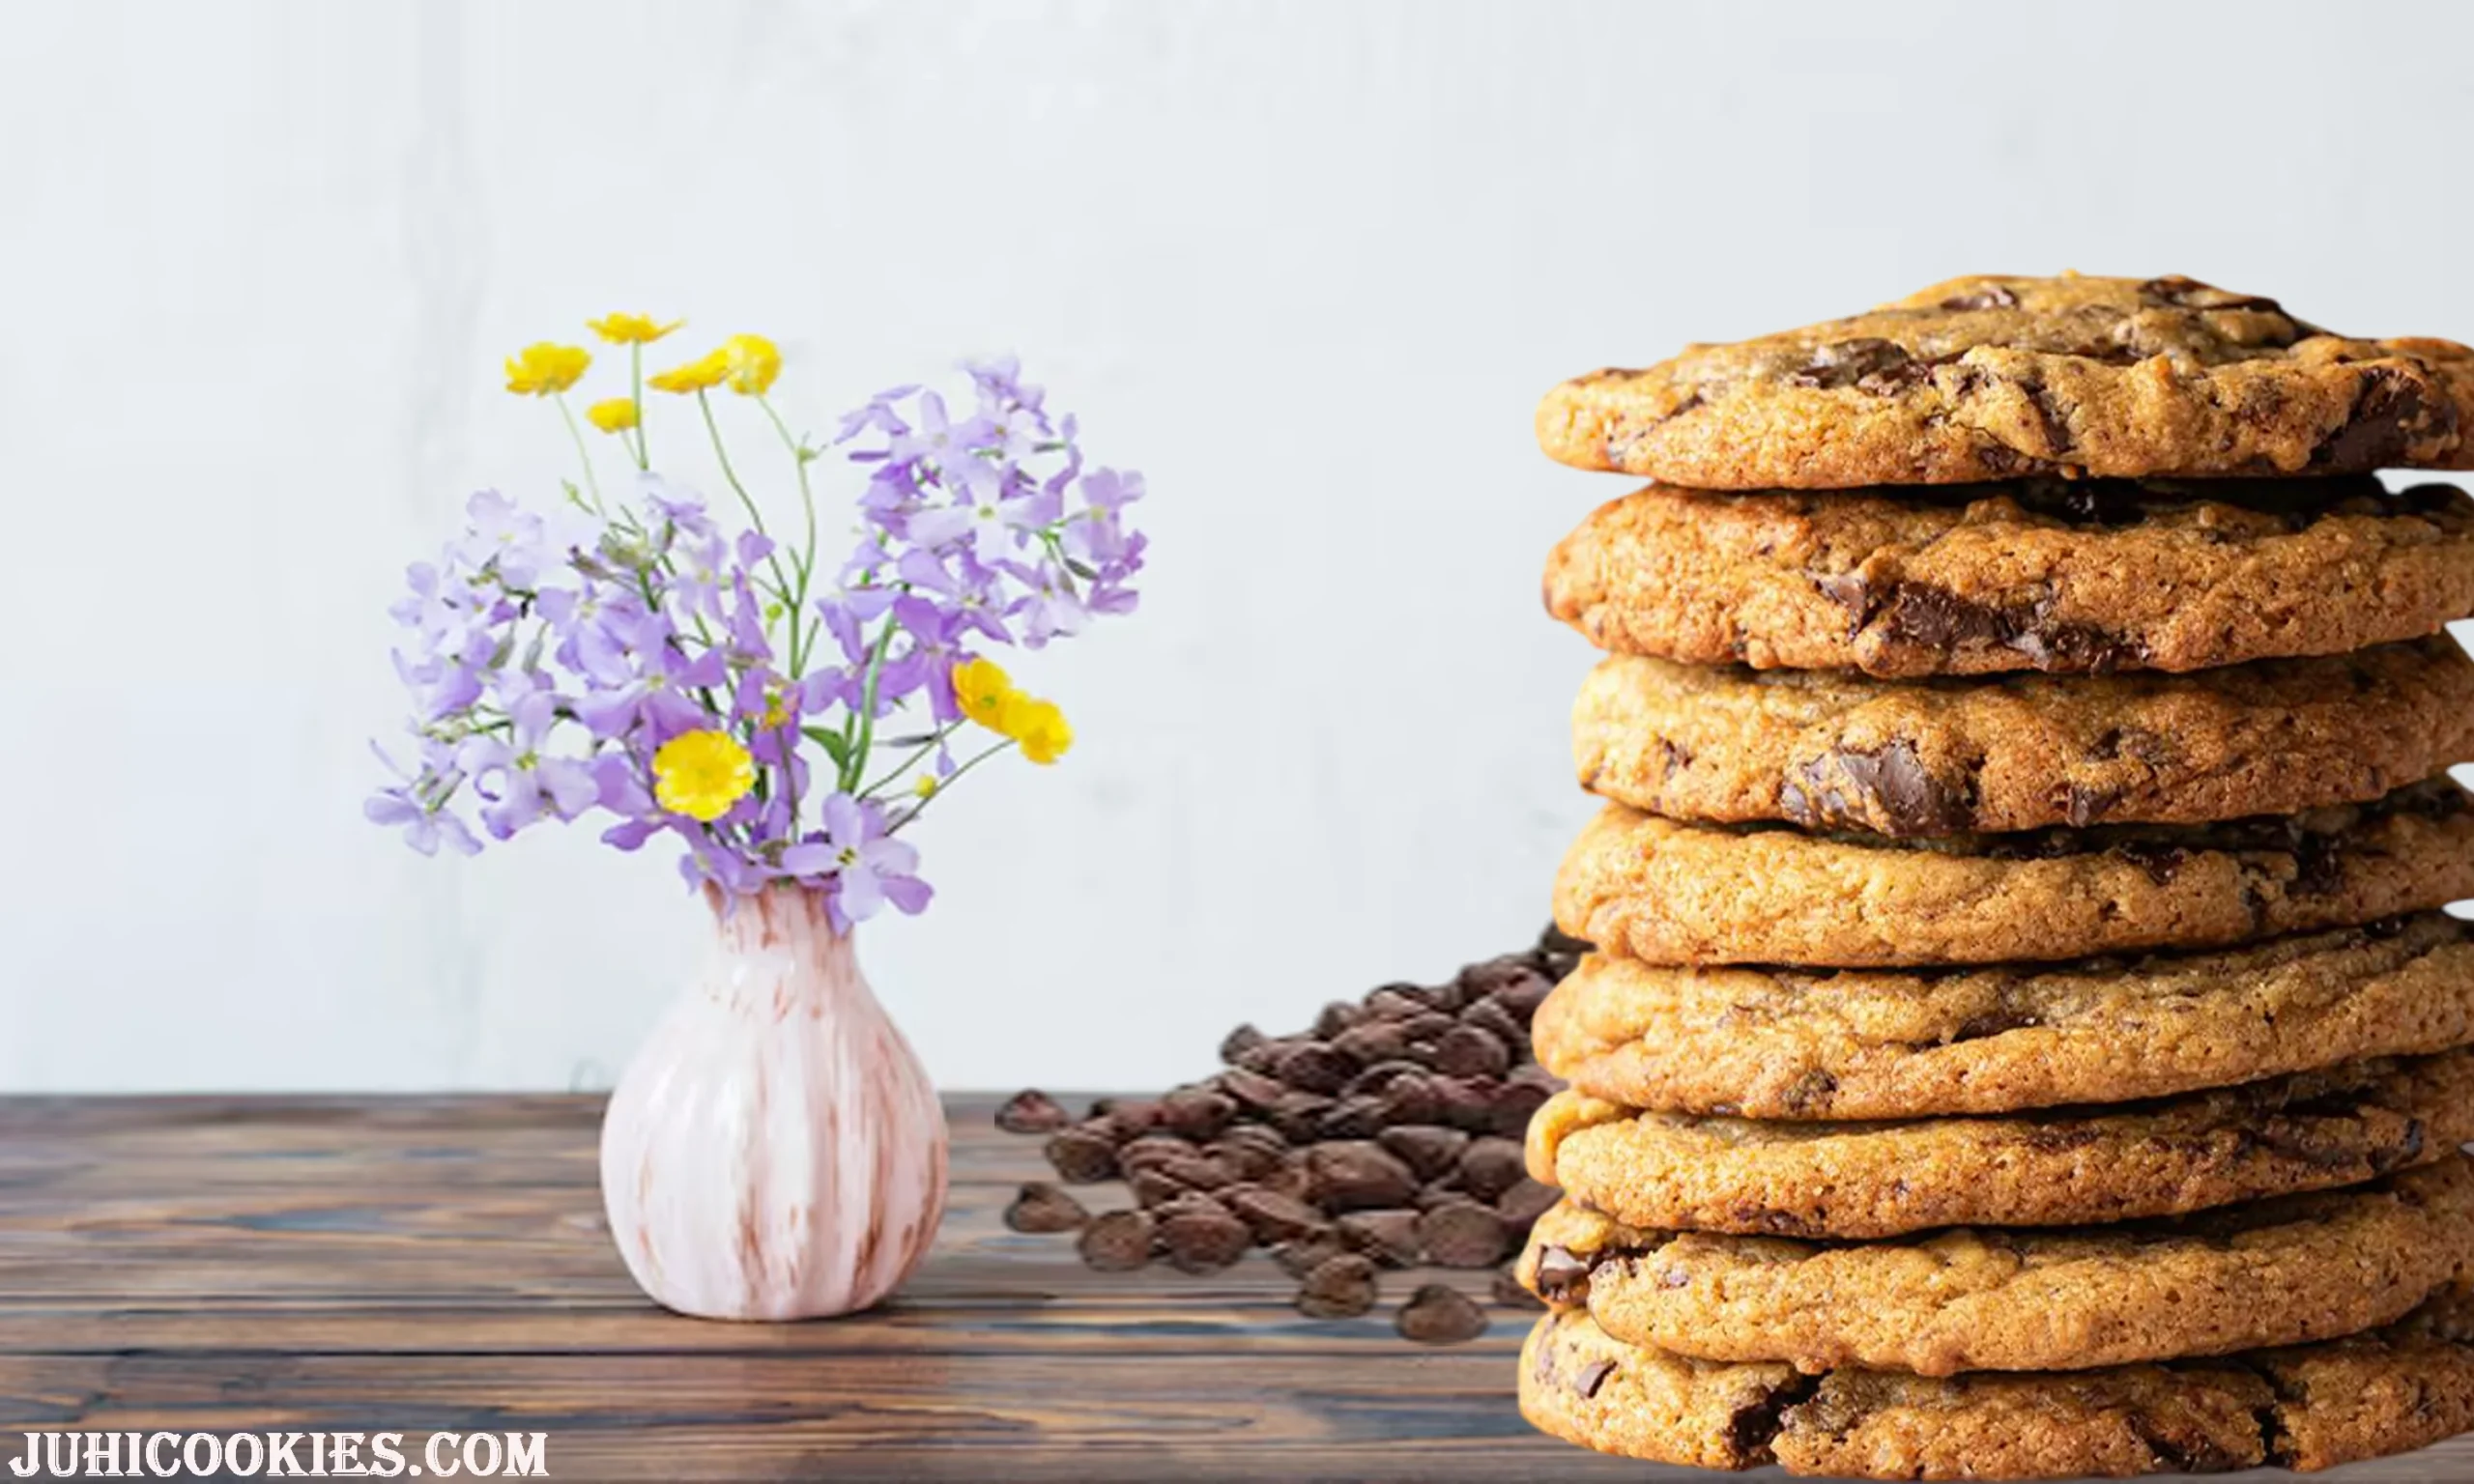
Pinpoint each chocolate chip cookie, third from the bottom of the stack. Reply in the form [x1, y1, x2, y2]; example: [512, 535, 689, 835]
[1527, 1051, 2474, 1240]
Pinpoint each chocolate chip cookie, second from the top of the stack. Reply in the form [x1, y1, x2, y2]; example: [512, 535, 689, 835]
[1543, 477, 2474, 677]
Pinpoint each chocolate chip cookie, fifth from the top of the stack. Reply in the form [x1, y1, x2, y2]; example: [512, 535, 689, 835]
[1532, 913, 2474, 1121]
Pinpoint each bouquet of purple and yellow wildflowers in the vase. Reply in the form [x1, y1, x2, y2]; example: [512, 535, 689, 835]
[366, 314, 1143, 930]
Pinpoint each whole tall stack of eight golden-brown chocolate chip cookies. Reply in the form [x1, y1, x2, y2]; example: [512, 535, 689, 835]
[1519, 277, 2474, 1479]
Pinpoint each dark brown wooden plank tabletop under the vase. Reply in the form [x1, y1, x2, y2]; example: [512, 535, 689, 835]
[0, 1096, 2474, 1484]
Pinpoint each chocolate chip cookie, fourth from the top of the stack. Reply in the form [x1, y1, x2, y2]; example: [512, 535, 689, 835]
[1554, 777, 2474, 967]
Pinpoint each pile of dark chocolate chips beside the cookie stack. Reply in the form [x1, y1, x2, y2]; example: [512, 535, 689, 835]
[997, 928, 1589, 1346]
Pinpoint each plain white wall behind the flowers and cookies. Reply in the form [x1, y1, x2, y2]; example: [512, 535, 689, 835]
[0, 0, 2474, 1091]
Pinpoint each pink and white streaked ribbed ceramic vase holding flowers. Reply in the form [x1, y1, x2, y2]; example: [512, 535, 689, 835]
[601, 885, 945, 1318]
